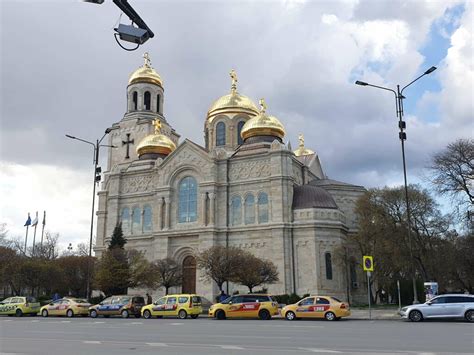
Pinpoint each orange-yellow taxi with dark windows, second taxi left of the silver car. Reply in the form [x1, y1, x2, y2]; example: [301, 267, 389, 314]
[209, 294, 278, 320]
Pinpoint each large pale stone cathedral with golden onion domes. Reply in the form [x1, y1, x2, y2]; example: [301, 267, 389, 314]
[94, 53, 365, 300]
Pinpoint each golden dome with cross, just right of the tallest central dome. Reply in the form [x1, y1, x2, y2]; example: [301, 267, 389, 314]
[240, 99, 286, 140]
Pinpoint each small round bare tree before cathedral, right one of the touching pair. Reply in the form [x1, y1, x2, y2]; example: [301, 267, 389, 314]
[236, 252, 278, 292]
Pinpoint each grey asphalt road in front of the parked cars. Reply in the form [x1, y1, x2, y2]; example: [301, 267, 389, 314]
[0, 317, 474, 355]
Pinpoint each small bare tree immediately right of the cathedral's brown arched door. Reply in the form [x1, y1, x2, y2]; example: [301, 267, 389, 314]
[196, 246, 242, 290]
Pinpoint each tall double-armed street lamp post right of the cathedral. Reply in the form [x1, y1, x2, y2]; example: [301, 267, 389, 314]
[355, 66, 436, 304]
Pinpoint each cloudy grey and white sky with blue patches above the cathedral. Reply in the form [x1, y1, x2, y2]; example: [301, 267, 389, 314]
[0, 0, 474, 252]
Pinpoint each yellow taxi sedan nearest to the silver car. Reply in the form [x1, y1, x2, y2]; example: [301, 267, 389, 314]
[281, 296, 351, 320]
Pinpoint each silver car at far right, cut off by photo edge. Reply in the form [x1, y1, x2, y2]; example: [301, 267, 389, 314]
[400, 294, 474, 322]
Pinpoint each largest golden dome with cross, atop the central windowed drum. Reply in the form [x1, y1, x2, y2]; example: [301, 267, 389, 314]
[207, 69, 258, 122]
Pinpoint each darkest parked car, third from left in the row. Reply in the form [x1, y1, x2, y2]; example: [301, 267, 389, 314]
[89, 295, 145, 318]
